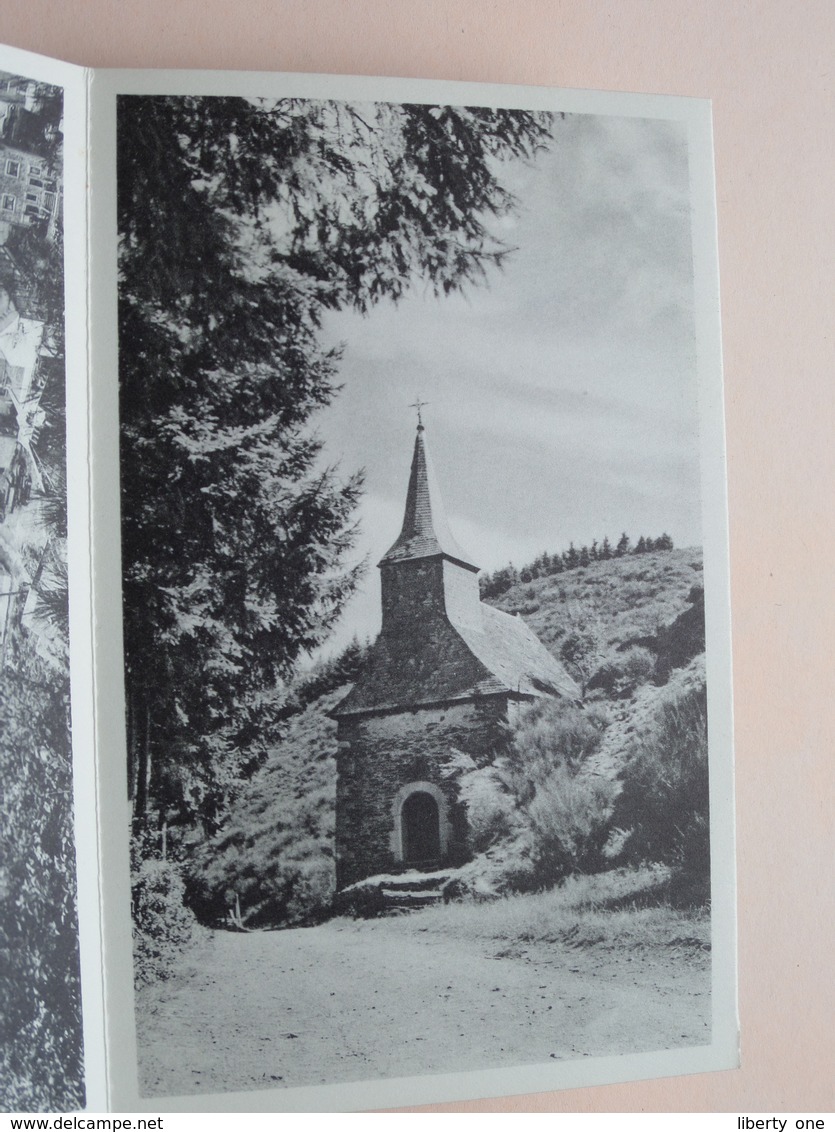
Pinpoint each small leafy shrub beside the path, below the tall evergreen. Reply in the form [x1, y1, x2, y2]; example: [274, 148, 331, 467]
[131, 857, 197, 985]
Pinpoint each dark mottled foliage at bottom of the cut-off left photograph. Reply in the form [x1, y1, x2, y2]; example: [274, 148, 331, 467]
[0, 635, 84, 1112]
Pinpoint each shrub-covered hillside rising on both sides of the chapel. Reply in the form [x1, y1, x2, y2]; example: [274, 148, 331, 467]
[134, 549, 708, 977]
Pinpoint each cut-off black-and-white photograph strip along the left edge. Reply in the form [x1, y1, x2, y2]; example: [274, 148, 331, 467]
[0, 71, 85, 1112]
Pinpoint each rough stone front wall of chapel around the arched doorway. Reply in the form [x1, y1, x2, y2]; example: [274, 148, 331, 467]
[336, 696, 513, 889]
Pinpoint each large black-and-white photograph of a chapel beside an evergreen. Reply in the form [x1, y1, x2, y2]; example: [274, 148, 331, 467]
[115, 82, 734, 1107]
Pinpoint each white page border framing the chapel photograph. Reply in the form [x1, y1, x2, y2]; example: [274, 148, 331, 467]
[85, 70, 739, 1112]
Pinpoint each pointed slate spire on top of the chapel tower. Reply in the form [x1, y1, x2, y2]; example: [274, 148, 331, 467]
[380, 420, 479, 569]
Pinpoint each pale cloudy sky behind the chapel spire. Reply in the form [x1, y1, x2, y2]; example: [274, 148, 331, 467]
[317, 108, 701, 652]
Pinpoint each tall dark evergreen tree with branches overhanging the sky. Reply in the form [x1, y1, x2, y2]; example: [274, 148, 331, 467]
[118, 96, 549, 834]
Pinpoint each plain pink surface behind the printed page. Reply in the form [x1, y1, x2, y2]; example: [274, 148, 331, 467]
[0, 0, 835, 1113]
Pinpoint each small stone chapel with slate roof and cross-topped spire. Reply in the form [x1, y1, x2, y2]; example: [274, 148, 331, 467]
[332, 421, 579, 890]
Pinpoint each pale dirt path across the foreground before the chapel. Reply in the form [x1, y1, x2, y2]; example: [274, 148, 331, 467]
[138, 917, 711, 1097]
